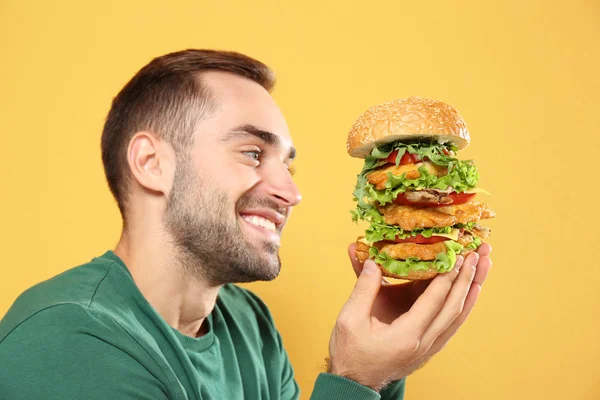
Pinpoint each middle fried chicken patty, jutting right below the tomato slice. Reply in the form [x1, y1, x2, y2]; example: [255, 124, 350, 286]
[379, 199, 496, 231]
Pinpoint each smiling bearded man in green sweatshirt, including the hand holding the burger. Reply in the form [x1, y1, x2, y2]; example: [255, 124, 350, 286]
[0, 50, 491, 400]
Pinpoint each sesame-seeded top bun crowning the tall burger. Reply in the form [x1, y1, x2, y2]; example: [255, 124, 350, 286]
[346, 97, 471, 158]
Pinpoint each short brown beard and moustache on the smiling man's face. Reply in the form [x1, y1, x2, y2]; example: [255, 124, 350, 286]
[164, 156, 285, 285]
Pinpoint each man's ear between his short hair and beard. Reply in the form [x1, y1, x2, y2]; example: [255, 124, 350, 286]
[127, 132, 174, 194]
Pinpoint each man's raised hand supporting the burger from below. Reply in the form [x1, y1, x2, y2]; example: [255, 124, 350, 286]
[329, 244, 492, 391]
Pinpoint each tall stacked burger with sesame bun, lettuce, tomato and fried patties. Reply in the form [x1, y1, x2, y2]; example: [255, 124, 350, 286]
[347, 97, 495, 280]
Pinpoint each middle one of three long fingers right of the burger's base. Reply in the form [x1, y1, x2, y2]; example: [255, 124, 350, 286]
[421, 253, 479, 348]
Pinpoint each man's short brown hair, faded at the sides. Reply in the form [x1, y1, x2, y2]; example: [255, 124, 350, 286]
[102, 49, 275, 221]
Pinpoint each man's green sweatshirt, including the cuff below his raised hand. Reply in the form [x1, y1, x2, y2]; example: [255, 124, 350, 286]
[0, 251, 404, 400]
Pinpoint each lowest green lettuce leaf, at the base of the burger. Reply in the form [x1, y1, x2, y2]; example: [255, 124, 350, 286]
[369, 240, 463, 276]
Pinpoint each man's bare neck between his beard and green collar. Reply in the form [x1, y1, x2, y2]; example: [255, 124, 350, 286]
[115, 225, 222, 337]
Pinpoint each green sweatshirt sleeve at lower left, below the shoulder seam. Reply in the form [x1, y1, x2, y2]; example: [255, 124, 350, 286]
[0, 304, 170, 400]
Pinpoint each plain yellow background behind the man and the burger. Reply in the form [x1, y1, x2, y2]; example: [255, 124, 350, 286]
[0, 0, 600, 400]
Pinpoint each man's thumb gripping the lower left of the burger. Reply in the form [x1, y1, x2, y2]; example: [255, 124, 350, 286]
[341, 260, 381, 318]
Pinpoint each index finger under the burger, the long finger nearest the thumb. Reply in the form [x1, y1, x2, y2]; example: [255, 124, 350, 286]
[394, 256, 463, 338]
